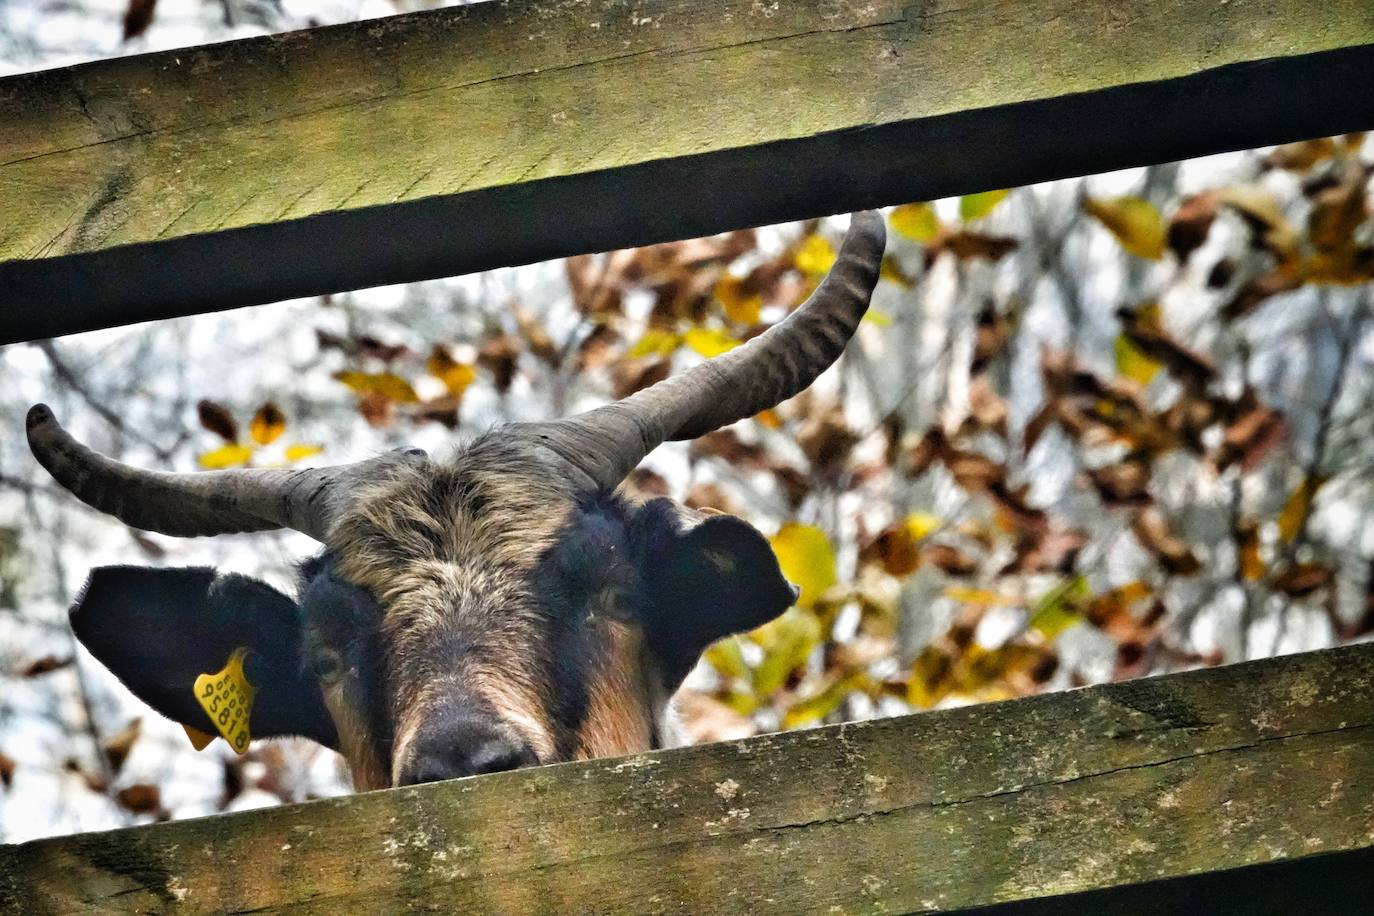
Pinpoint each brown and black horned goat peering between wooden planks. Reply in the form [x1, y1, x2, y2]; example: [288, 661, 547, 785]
[26, 211, 885, 790]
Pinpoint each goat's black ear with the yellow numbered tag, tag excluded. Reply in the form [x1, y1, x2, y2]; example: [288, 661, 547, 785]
[71, 566, 338, 747]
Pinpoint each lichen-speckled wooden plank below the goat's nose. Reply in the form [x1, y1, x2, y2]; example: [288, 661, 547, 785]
[0, 644, 1374, 913]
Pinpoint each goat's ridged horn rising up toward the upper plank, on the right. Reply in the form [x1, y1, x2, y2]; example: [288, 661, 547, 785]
[521, 210, 886, 489]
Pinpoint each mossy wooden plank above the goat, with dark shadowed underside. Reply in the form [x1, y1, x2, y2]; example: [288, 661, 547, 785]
[0, 0, 1374, 343]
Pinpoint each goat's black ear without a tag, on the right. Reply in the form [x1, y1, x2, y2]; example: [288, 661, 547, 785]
[633, 499, 797, 687]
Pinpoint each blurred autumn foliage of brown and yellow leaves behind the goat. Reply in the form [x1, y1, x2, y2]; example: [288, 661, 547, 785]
[0, 0, 1374, 840]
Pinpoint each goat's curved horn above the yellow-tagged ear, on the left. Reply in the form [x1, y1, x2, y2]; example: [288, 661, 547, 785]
[25, 404, 396, 541]
